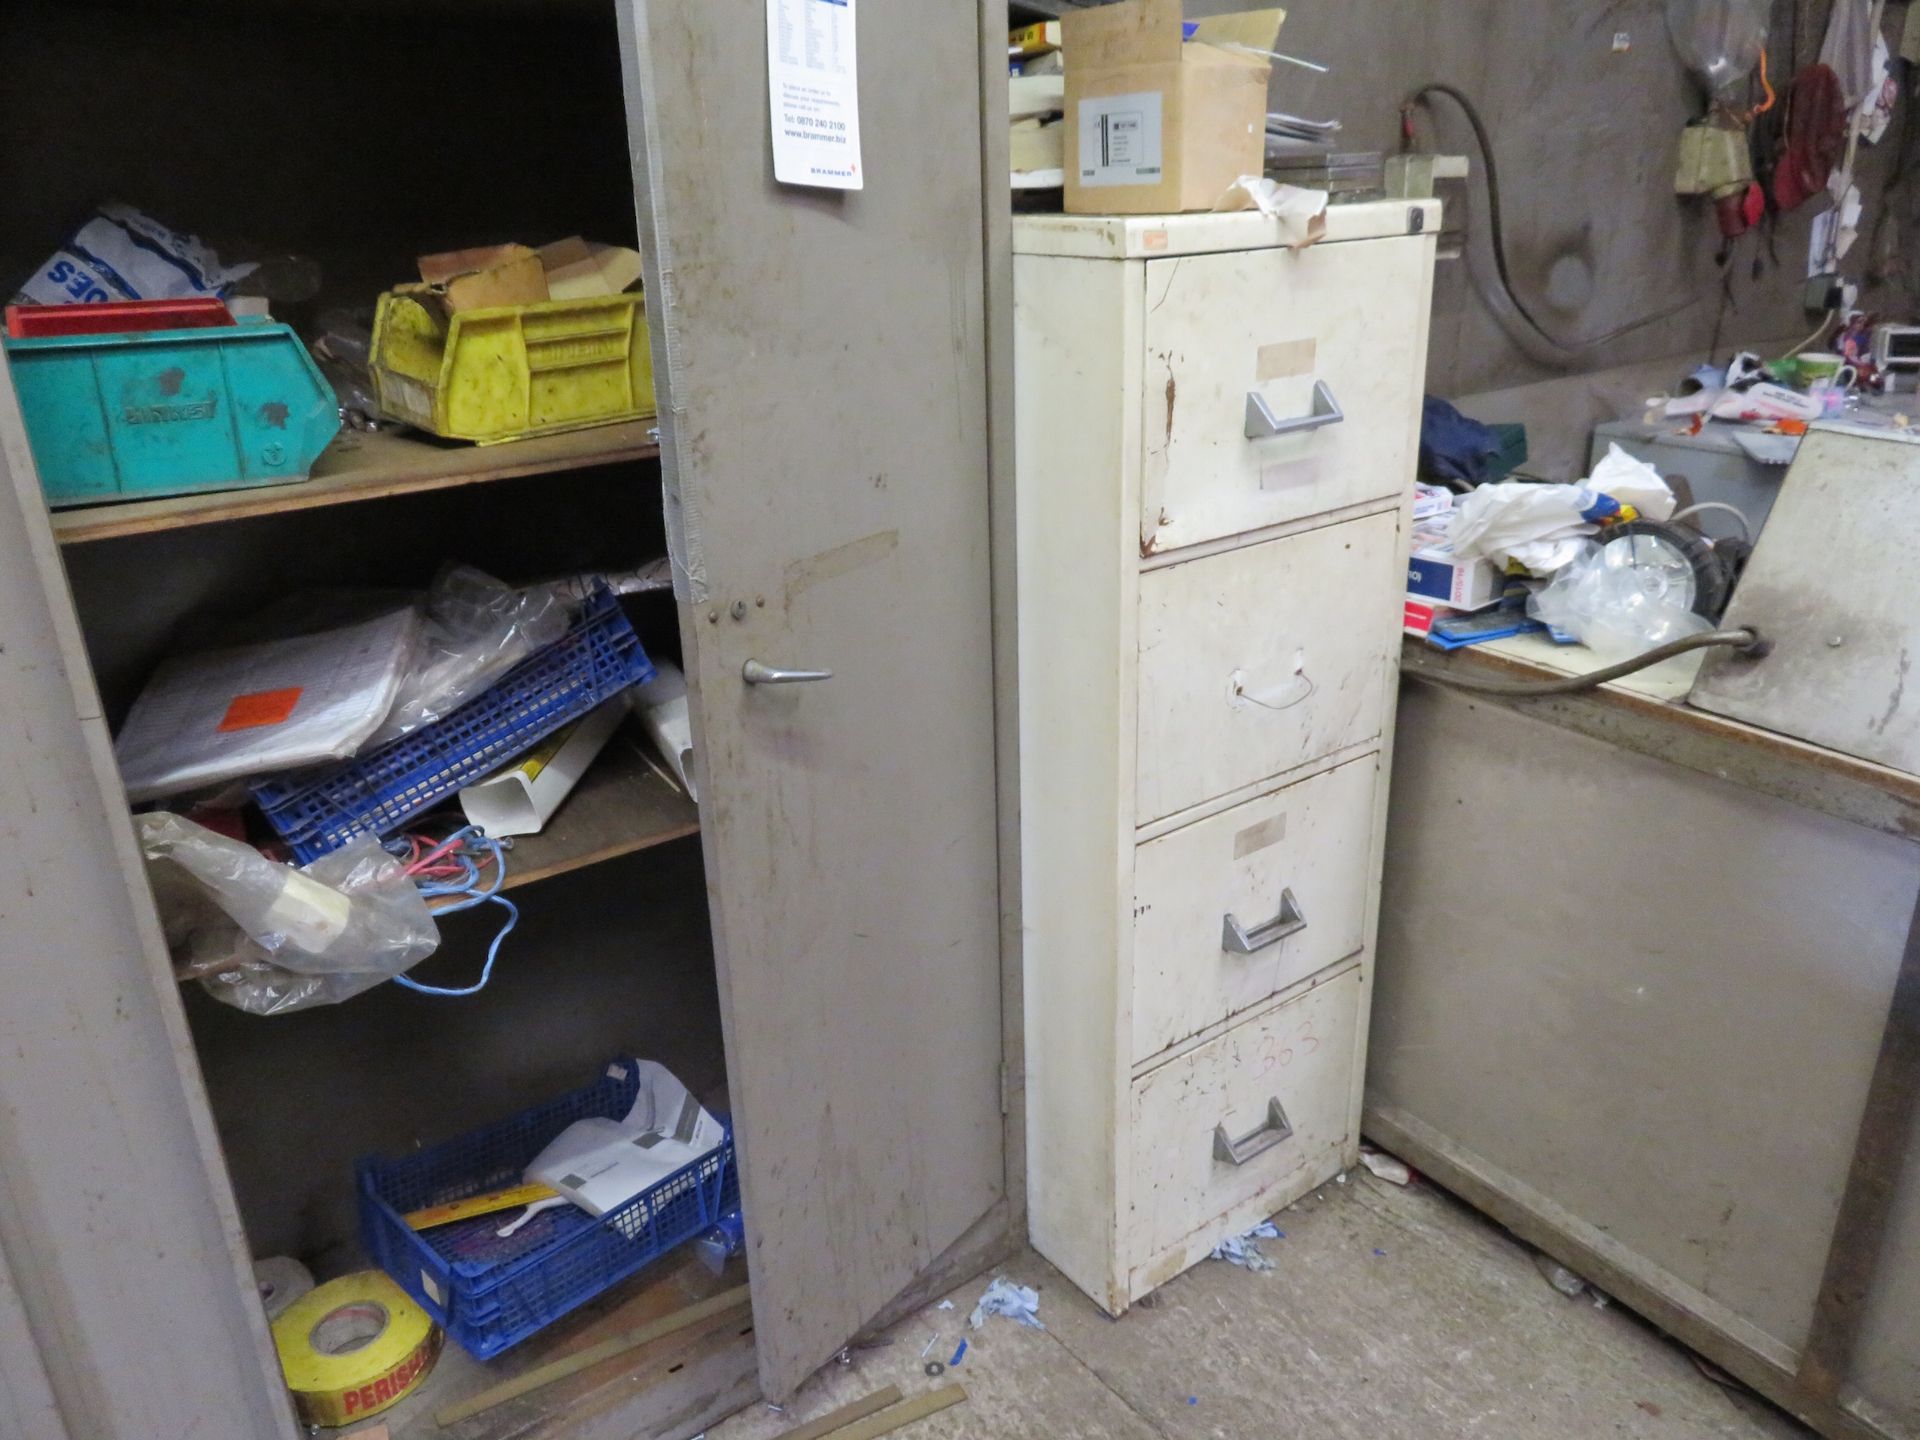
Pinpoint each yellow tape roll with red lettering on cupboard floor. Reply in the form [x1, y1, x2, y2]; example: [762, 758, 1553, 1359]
[273, 1269, 440, 1427]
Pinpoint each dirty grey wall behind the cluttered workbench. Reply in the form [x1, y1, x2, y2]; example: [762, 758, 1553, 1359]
[1188, 0, 1910, 396]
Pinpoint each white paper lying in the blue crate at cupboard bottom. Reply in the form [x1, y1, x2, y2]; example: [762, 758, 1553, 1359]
[526, 1060, 726, 1215]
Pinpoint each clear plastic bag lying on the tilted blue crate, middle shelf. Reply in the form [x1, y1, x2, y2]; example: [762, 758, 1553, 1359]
[361, 564, 568, 751]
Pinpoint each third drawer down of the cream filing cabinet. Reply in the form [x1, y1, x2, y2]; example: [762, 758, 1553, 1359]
[1133, 755, 1380, 1066]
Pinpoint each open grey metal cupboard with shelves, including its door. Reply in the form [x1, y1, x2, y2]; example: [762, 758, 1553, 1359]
[0, 0, 1025, 1440]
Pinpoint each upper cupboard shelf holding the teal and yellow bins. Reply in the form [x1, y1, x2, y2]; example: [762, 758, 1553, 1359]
[52, 420, 660, 545]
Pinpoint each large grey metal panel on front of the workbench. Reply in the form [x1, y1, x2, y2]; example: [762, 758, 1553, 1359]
[1367, 684, 1920, 1367]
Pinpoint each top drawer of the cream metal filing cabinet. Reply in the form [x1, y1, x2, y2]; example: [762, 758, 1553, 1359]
[1140, 236, 1432, 555]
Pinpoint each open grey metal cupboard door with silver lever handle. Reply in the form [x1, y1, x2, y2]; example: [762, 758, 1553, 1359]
[622, 0, 1006, 1396]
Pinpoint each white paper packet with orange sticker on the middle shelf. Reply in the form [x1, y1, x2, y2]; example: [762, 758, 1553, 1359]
[113, 609, 420, 803]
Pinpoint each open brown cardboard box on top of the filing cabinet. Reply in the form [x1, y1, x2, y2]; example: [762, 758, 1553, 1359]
[1062, 0, 1286, 215]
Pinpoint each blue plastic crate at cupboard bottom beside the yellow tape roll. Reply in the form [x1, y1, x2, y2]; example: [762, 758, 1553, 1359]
[355, 1060, 739, 1359]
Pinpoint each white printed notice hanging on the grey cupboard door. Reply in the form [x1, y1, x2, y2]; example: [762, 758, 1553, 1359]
[766, 0, 864, 190]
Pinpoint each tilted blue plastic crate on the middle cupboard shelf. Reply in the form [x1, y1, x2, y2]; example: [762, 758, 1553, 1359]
[253, 586, 653, 864]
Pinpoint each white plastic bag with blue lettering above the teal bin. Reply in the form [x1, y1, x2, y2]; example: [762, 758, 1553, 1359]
[13, 205, 253, 305]
